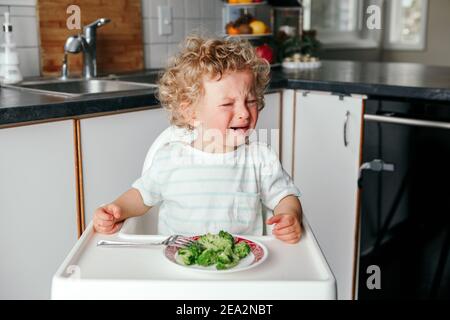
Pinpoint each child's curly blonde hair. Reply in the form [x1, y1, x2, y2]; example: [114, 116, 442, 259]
[156, 35, 270, 129]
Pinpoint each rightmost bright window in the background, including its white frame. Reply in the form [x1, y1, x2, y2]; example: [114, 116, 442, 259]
[384, 0, 428, 50]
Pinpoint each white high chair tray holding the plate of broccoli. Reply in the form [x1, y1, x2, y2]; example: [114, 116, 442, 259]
[52, 216, 336, 300]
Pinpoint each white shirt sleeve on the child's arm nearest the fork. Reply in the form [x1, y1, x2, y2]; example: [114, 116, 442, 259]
[132, 152, 162, 207]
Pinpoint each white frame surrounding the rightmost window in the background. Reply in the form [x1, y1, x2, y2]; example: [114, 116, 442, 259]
[383, 0, 429, 51]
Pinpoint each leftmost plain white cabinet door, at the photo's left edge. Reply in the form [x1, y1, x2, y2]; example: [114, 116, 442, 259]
[0, 121, 77, 299]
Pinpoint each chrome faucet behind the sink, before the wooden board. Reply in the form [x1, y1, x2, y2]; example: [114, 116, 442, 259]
[61, 18, 111, 79]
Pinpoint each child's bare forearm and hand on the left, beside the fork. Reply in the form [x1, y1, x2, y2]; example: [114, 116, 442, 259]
[93, 188, 151, 234]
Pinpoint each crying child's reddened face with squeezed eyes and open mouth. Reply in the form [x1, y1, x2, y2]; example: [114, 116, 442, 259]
[195, 71, 258, 152]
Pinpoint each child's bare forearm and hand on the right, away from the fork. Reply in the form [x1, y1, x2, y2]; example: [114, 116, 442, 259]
[267, 195, 303, 244]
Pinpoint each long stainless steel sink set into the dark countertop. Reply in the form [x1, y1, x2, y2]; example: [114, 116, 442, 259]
[4, 79, 156, 97]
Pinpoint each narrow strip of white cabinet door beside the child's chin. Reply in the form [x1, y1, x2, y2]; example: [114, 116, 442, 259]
[256, 92, 281, 156]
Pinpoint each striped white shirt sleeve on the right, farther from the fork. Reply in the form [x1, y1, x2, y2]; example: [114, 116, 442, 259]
[261, 147, 301, 210]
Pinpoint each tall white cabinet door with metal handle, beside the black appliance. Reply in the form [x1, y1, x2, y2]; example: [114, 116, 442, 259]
[294, 92, 363, 299]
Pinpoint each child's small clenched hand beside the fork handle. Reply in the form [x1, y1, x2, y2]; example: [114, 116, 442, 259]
[94, 203, 123, 234]
